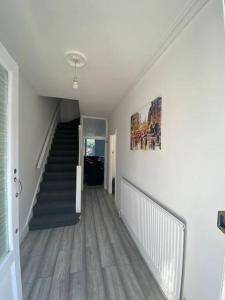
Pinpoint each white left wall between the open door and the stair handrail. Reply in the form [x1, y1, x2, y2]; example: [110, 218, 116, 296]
[19, 73, 59, 239]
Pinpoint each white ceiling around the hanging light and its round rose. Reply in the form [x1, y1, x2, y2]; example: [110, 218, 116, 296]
[0, 0, 193, 116]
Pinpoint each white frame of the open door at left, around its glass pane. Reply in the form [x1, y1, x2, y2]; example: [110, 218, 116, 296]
[0, 43, 22, 300]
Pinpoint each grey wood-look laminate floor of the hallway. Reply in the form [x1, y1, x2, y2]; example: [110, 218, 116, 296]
[21, 188, 165, 300]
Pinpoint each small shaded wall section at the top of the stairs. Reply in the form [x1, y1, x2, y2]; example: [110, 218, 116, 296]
[60, 99, 80, 122]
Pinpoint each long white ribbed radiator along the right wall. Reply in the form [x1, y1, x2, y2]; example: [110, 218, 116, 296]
[121, 179, 185, 300]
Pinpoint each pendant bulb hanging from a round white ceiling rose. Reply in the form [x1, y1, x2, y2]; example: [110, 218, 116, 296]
[64, 50, 87, 89]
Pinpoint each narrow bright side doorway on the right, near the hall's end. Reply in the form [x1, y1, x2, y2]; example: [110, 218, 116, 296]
[108, 133, 116, 197]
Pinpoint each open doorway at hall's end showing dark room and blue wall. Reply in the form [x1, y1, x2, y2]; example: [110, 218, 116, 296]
[84, 138, 105, 185]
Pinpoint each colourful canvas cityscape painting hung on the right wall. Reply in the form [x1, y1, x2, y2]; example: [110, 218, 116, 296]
[130, 97, 162, 150]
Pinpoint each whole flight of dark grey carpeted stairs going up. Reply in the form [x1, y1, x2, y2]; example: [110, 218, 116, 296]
[29, 119, 80, 230]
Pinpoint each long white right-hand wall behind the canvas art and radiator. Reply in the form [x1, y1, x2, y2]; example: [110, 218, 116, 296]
[109, 0, 225, 300]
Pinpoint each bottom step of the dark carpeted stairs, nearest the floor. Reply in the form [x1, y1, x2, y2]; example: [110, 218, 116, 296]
[29, 213, 79, 230]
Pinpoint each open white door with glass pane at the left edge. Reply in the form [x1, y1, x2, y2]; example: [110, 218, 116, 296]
[0, 43, 22, 300]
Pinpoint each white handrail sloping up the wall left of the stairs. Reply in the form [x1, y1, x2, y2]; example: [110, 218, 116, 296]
[37, 104, 60, 169]
